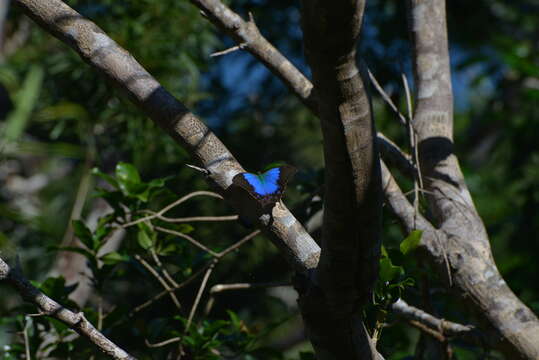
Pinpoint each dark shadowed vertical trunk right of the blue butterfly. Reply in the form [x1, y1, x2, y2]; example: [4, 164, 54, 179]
[299, 1, 382, 359]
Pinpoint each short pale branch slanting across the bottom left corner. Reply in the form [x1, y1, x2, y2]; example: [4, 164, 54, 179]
[0, 258, 135, 359]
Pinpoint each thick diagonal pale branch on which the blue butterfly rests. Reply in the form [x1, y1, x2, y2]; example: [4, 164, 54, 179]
[14, 0, 320, 271]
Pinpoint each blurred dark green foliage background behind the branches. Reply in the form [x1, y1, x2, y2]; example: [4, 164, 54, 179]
[0, 0, 539, 359]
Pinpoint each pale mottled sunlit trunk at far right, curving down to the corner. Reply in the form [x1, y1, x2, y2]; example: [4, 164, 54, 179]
[408, 0, 539, 359]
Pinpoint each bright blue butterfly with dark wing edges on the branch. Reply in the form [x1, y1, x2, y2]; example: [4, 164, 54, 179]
[232, 165, 296, 210]
